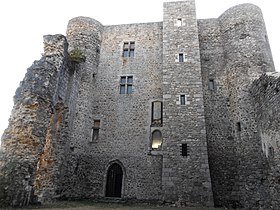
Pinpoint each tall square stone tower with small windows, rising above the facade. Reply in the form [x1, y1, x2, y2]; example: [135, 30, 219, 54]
[162, 0, 213, 206]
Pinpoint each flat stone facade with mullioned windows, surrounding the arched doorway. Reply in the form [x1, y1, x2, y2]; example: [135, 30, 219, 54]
[60, 20, 165, 200]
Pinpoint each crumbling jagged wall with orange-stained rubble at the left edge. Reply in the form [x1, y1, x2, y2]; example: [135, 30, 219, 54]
[0, 35, 70, 206]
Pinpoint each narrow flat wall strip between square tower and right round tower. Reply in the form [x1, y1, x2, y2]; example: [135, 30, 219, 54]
[198, 19, 235, 206]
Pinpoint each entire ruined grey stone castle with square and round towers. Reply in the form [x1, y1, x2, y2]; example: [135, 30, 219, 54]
[0, 0, 280, 209]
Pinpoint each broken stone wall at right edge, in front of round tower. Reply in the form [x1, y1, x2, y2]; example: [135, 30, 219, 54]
[250, 72, 280, 209]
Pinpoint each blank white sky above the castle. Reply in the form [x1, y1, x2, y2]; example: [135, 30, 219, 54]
[0, 0, 280, 137]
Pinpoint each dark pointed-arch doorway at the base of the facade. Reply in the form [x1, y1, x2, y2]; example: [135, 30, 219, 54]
[105, 163, 123, 198]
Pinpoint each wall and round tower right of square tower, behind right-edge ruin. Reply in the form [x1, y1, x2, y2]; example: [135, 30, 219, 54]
[199, 4, 274, 209]
